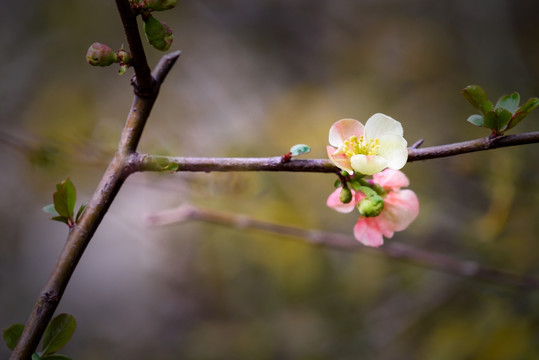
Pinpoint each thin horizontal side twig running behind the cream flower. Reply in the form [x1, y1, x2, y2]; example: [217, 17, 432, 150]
[132, 131, 539, 173]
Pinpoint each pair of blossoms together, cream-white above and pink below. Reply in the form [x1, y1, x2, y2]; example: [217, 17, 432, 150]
[327, 114, 419, 247]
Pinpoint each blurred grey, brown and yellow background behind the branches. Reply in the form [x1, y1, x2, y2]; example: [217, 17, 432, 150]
[0, 0, 539, 360]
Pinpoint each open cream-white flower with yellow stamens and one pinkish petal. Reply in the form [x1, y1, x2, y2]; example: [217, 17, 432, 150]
[327, 114, 408, 175]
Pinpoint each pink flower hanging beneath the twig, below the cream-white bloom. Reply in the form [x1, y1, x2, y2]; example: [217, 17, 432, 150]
[327, 169, 419, 247]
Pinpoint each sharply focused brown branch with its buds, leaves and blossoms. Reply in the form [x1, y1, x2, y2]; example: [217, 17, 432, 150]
[10, 0, 539, 360]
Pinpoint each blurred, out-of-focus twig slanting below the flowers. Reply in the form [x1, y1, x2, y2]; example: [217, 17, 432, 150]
[146, 205, 539, 289]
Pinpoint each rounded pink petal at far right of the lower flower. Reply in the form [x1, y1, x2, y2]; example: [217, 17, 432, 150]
[378, 189, 419, 232]
